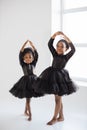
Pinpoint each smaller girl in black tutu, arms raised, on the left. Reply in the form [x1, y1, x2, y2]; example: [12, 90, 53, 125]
[10, 40, 40, 120]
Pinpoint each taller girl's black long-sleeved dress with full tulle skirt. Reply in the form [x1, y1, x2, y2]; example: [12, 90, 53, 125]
[33, 39, 78, 96]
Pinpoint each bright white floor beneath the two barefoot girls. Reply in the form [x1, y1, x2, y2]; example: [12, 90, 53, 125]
[0, 87, 87, 130]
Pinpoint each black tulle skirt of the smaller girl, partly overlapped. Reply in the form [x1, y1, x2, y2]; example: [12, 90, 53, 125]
[9, 74, 43, 98]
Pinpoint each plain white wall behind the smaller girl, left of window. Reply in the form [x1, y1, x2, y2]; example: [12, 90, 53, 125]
[0, 0, 51, 99]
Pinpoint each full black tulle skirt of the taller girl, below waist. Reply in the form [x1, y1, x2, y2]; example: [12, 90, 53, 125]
[33, 67, 78, 96]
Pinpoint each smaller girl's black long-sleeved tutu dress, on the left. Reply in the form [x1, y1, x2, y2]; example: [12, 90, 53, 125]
[9, 48, 42, 98]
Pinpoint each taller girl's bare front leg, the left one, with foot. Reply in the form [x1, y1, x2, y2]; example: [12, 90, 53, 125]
[47, 95, 62, 125]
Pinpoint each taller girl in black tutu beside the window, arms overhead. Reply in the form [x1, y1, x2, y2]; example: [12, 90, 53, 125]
[33, 32, 77, 125]
